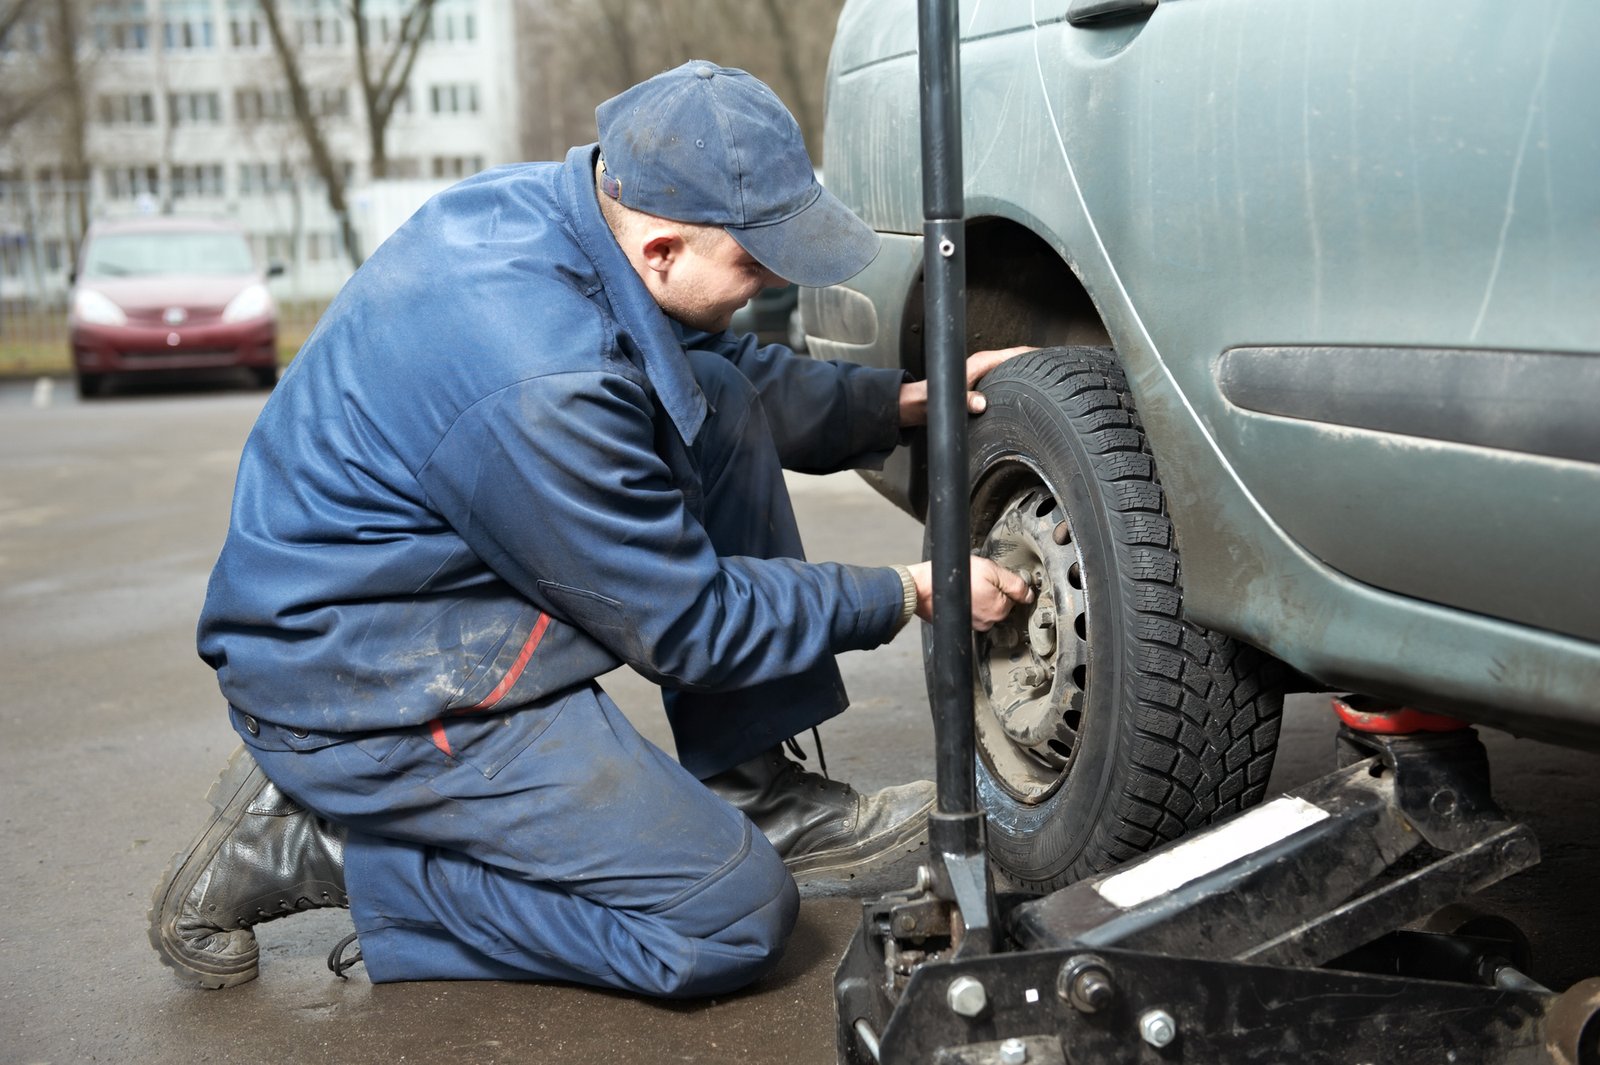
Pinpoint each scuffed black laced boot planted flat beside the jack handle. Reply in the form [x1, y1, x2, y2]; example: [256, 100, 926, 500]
[704, 747, 934, 884]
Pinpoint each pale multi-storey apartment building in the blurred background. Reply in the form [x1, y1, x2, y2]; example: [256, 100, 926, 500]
[0, 0, 520, 297]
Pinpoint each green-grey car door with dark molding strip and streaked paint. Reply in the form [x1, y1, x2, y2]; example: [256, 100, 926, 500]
[1062, 0, 1600, 640]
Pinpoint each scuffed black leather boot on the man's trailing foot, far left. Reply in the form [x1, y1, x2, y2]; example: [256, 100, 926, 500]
[150, 747, 350, 988]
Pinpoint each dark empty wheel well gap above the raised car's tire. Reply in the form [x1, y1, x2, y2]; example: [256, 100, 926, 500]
[901, 217, 1110, 377]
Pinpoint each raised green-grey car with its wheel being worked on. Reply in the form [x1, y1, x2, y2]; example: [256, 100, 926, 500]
[812, 0, 1600, 891]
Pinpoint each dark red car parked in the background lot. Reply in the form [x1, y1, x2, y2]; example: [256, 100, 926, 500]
[67, 216, 283, 398]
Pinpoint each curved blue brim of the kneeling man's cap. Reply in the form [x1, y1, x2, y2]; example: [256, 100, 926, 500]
[725, 185, 878, 288]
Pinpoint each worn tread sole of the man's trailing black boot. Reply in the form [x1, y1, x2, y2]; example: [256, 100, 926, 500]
[150, 747, 267, 990]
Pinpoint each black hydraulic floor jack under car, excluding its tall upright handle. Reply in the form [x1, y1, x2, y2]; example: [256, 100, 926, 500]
[835, 700, 1600, 1065]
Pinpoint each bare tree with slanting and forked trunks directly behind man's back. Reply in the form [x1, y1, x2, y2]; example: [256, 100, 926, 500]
[258, 0, 435, 265]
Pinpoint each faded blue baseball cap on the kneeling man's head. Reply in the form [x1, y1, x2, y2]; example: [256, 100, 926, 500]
[595, 59, 878, 288]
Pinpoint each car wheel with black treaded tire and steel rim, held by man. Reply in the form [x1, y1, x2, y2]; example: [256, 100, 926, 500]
[947, 347, 1283, 891]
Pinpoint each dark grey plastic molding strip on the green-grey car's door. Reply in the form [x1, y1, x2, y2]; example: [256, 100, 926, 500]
[1216, 347, 1600, 464]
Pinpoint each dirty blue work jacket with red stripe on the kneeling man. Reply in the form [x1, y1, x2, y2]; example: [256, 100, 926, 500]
[198, 146, 901, 744]
